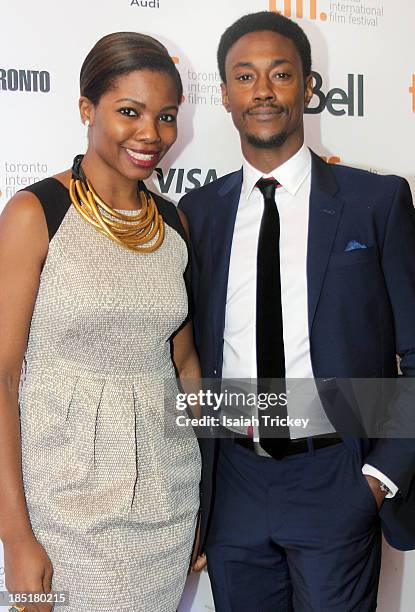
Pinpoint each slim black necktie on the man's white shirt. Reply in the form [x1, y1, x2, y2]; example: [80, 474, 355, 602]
[256, 179, 289, 459]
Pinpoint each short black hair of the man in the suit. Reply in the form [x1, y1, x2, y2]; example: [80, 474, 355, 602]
[218, 11, 311, 83]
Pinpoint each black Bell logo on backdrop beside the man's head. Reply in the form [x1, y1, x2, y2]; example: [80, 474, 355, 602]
[304, 71, 364, 117]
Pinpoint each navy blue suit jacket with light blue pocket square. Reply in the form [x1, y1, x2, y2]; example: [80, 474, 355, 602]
[179, 153, 415, 550]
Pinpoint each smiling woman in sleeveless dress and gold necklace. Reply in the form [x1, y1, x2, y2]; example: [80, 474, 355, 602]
[0, 33, 200, 612]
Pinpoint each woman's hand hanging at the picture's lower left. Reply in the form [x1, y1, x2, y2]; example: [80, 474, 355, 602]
[3, 536, 53, 612]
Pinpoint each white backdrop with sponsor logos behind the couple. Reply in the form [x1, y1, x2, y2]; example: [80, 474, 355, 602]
[0, 0, 415, 612]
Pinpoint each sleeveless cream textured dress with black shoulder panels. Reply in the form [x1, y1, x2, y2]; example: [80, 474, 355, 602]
[20, 178, 200, 612]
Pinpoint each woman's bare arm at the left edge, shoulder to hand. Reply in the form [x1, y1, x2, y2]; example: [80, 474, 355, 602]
[0, 192, 52, 610]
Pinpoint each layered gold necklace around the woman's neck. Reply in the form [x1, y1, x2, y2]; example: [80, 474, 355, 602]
[69, 155, 164, 253]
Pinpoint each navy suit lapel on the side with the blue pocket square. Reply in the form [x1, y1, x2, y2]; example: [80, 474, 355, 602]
[307, 152, 344, 335]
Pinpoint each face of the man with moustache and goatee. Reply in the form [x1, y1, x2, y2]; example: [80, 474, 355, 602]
[222, 30, 313, 154]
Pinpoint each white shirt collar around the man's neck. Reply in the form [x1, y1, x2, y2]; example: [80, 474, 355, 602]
[242, 144, 311, 199]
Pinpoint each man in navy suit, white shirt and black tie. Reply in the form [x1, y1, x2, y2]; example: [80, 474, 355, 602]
[180, 12, 415, 612]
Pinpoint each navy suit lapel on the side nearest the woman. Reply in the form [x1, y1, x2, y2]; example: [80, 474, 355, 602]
[211, 169, 242, 346]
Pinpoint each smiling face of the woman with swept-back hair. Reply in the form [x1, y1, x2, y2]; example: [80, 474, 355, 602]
[80, 70, 178, 181]
